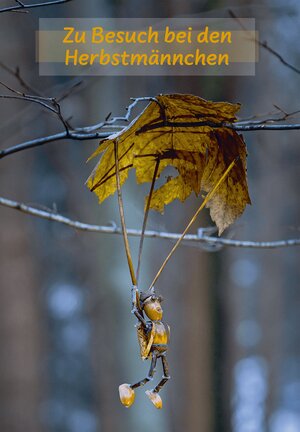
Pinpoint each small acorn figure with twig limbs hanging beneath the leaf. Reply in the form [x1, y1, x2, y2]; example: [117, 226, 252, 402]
[119, 286, 170, 409]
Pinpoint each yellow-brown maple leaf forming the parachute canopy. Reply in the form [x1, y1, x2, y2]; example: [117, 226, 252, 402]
[87, 94, 250, 234]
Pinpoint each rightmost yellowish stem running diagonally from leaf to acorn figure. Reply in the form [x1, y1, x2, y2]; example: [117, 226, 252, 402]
[149, 160, 236, 289]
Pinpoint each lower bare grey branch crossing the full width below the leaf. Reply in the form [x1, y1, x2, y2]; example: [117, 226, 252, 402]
[0, 197, 300, 249]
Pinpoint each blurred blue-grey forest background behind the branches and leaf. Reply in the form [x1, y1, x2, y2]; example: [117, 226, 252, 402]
[0, 0, 300, 432]
